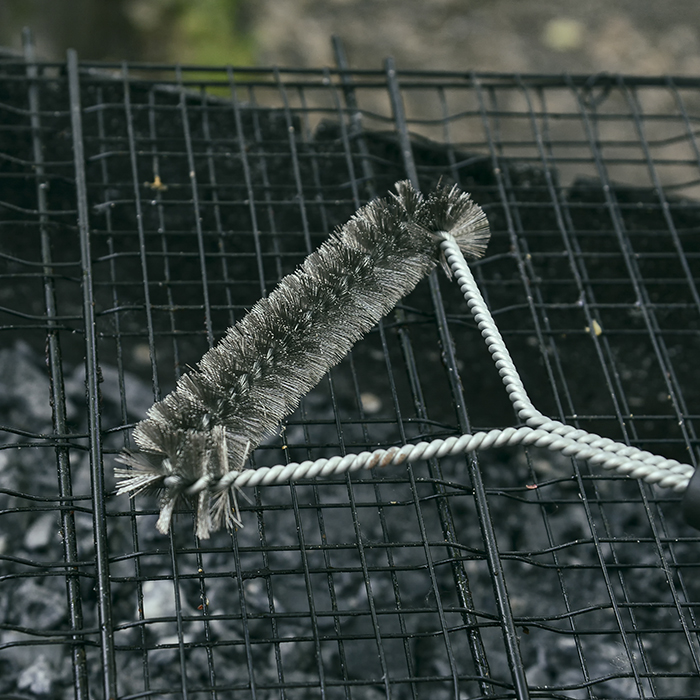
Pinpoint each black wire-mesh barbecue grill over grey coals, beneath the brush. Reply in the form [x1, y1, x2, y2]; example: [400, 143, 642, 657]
[0, 35, 700, 700]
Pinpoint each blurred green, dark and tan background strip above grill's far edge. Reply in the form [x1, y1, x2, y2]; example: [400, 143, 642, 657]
[0, 0, 700, 75]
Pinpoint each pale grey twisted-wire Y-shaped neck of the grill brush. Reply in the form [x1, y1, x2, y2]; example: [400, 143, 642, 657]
[197, 232, 695, 495]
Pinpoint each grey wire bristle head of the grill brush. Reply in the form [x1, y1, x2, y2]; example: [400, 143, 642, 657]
[115, 181, 489, 538]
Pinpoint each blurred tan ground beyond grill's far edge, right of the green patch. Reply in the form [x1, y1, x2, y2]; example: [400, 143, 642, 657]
[253, 0, 700, 75]
